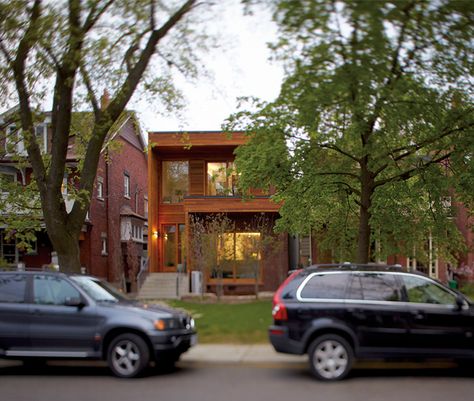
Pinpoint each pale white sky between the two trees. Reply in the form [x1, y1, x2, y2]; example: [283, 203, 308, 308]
[130, 0, 283, 131]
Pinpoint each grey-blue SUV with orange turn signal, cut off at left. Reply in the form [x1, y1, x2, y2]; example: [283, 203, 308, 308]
[0, 272, 197, 377]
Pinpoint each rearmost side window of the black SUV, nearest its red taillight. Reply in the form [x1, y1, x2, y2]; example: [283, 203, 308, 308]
[301, 273, 349, 299]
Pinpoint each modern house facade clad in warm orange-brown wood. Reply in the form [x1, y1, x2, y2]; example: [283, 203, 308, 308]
[148, 132, 288, 293]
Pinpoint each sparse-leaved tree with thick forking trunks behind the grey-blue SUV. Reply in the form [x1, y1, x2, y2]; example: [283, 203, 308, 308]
[0, 0, 205, 272]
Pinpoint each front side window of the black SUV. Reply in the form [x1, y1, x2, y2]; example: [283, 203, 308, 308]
[403, 276, 456, 305]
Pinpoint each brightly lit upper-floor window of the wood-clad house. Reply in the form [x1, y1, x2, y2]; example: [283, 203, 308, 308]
[206, 162, 238, 196]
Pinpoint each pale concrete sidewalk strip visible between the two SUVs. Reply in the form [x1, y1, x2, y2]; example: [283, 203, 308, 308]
[181, 344, 308, 363]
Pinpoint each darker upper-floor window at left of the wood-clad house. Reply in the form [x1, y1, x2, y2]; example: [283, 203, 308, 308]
[161, 161, 189, 203]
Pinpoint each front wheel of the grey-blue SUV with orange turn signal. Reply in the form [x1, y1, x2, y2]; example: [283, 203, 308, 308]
[107, 334, 150, 378]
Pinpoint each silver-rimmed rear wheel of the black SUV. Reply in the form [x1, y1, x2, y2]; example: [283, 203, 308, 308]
[308, 334, 354, 380]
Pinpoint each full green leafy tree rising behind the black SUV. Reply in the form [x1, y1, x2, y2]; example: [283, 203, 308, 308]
[226, 0, 474, 263]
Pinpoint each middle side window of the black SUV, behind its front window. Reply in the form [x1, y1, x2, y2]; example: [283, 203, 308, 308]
[347, 273, 401, 302]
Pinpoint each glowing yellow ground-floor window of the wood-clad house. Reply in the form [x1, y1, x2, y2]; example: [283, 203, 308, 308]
[211, 232, 260, 280]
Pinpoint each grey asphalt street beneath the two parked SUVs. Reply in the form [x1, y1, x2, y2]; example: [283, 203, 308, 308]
[0, 360, 474, 401]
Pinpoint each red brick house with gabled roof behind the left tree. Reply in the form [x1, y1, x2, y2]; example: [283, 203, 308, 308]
[0, 112, 148, 290]
